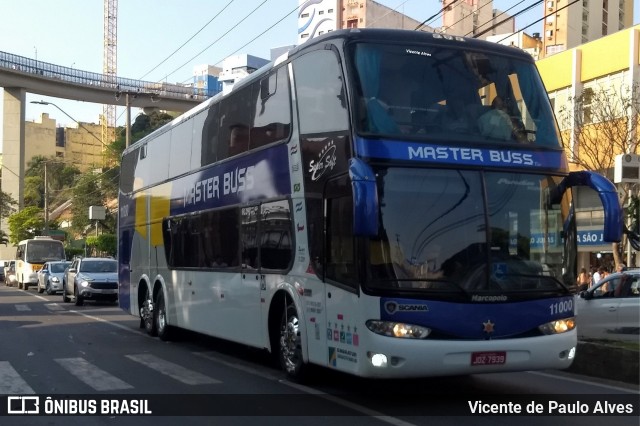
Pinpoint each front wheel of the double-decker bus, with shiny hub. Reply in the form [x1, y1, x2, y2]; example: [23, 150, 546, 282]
[278, 303, 307, 381]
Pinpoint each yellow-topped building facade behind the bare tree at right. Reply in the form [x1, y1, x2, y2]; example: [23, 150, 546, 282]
[536, 25, 640, 268]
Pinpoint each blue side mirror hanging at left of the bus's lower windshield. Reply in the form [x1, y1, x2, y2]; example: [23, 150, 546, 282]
[349, 158, 378, 237]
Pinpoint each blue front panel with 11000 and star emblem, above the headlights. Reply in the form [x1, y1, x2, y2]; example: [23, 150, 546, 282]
[380, 296, 575, 339]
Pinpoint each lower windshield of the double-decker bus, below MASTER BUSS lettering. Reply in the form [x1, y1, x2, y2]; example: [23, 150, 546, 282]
[366, 167, 575, 300]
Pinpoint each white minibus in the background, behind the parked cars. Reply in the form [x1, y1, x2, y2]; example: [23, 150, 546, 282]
[16, 236, 65, 290]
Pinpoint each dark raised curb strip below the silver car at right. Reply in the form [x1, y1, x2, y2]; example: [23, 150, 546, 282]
[566, 342, 640, 384]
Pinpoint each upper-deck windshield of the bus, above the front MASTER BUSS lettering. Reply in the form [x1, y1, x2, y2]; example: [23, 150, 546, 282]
[351, 43, 560, 148]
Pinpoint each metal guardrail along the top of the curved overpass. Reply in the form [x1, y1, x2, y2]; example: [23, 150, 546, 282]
[0, 52, 217, 100]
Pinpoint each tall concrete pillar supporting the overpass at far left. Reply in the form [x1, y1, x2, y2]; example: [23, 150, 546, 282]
[1, 87, 26, 211]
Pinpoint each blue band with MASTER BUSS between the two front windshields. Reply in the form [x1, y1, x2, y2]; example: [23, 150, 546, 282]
[355, 137, 567, 170]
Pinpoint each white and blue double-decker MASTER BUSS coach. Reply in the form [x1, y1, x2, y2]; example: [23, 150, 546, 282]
[118, 29, 623, 378]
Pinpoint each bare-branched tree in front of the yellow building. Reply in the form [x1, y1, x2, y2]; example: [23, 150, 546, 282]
[560, 84, 640, 265]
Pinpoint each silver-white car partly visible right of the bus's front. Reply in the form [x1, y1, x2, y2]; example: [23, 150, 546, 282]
[576, 271, 640, 342]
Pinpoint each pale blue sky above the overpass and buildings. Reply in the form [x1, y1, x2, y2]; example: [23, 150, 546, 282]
[0, 0, 640, 147]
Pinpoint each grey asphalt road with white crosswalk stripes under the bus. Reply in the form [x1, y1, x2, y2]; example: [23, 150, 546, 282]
[0, 285, 640, 426]
